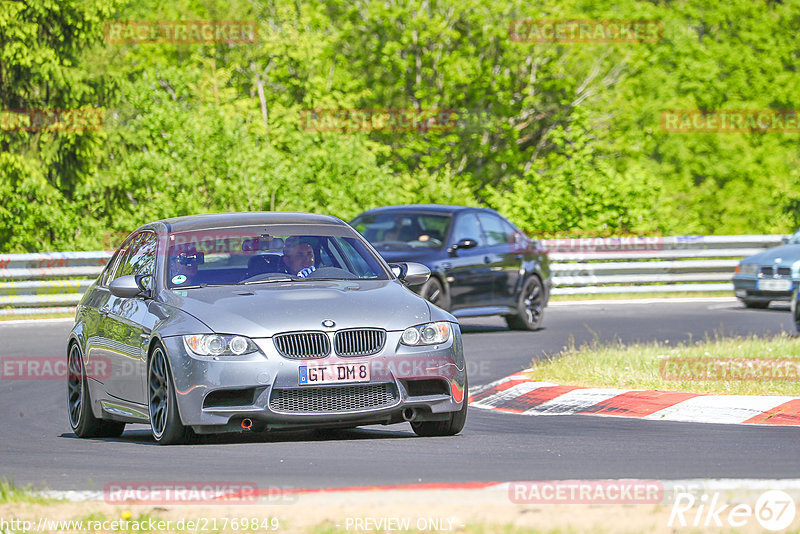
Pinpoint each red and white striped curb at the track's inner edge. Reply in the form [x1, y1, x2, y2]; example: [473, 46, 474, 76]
[469, 371, 800, 426]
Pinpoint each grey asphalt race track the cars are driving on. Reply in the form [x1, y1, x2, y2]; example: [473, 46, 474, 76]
[0, 301, 800, 490]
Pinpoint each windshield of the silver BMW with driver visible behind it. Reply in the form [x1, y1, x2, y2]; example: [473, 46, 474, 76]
[167, 226, 389, 289]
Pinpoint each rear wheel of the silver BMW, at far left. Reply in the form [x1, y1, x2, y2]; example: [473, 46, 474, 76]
[67, 343, 125, 438]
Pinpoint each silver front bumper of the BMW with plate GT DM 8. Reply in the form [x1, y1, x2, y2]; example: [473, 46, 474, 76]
[163, 324, 467, 433]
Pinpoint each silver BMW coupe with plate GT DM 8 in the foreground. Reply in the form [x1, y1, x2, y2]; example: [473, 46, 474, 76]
[67, 212, 467, 444]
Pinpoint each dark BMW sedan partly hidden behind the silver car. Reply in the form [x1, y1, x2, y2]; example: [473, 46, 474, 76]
[350, 204, 551, 330]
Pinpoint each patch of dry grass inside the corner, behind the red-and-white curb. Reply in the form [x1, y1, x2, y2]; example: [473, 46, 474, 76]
[527, 333, 800, 396]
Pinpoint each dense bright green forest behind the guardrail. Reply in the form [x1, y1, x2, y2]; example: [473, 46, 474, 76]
[0, 0, 800, 252]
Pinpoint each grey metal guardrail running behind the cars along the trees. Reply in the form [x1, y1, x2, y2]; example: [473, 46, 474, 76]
[0, 235, 788, 315]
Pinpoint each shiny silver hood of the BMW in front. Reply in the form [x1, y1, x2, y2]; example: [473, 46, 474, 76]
[161, 280, 430, 337]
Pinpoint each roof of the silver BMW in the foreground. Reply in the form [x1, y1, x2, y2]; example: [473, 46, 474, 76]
[155, 211, 345, 232]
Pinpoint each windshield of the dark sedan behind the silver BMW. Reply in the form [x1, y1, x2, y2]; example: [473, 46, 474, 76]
[350, 212, 450, 248]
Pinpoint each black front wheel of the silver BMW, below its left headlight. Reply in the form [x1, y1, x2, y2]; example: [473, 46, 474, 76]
[147, 346, 191, 445]
